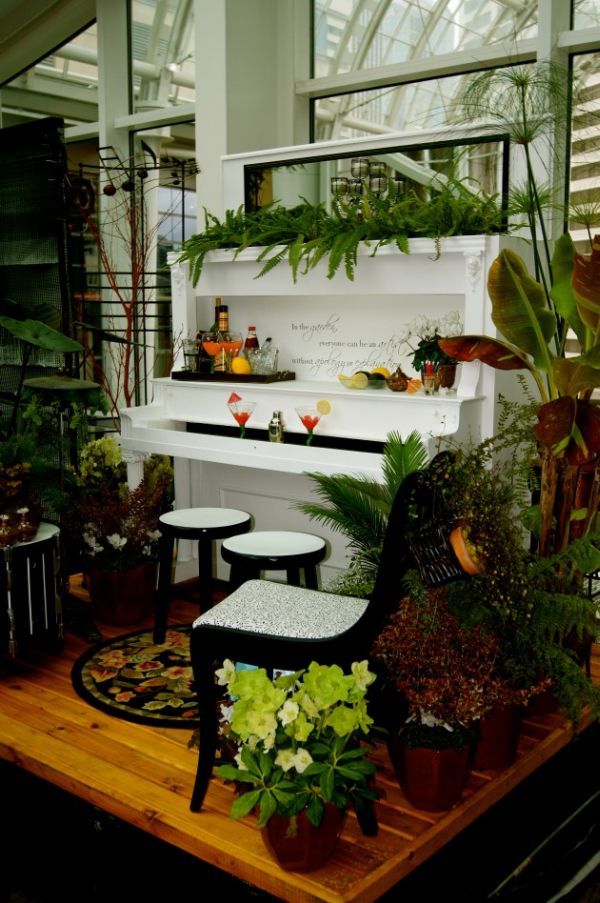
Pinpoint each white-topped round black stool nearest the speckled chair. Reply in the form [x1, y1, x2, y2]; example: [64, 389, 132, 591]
[221, 530, 327, 589]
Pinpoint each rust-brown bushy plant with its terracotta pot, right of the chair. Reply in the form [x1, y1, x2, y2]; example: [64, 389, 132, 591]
[373, 584, 548, 811]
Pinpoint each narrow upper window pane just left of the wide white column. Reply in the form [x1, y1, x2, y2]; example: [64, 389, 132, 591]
[131, 0, 195, 109]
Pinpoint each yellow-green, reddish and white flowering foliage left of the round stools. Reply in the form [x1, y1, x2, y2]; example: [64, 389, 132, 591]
[69, 436, 173, 570]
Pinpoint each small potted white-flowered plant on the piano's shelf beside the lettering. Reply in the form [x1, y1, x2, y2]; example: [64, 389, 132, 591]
[400, 310, 463, 389]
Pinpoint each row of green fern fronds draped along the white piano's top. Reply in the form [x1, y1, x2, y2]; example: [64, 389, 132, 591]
[179, 179, 503, 285]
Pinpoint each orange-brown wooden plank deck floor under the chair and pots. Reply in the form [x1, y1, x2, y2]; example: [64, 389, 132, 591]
[0, 603, 600, 903]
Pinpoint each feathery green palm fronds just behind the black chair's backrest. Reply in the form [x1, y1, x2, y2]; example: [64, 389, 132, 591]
[296, 431, 429, 592]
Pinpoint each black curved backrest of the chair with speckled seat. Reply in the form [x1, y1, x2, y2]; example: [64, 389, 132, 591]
[361, 451, 465, 639]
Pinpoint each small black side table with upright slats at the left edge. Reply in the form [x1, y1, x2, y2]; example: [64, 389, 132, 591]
[0, 522, 63, 657]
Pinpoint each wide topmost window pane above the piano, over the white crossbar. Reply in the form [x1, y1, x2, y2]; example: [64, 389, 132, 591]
[314, 0, 540, 78]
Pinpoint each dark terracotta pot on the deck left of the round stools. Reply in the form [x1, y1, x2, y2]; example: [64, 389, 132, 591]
[87, 562, 157, 625]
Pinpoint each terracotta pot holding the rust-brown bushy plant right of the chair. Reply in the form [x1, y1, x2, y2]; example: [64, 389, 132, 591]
[389, 738, 470, 812]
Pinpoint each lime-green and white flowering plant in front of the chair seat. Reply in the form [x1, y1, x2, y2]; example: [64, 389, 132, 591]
[217, 659, 377, 827]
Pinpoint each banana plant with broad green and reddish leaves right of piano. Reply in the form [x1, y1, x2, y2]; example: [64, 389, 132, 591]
[439, 234, 600, 556]
